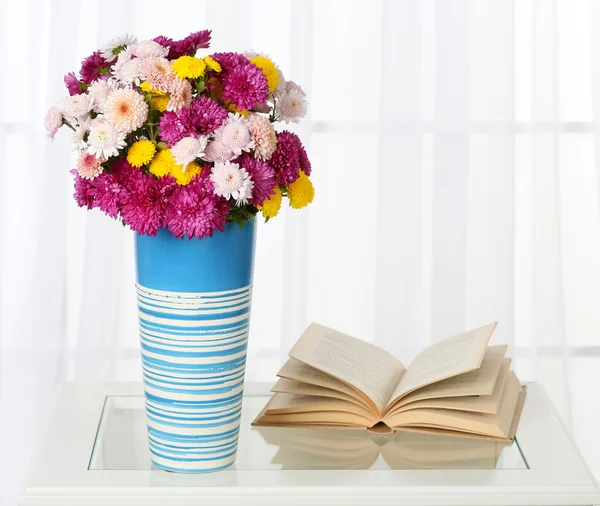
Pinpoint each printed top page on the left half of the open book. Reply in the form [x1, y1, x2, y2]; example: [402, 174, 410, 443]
[289, 323, 404, 413]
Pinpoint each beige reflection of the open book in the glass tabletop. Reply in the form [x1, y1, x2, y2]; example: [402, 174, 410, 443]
[254, 427, 508, 470]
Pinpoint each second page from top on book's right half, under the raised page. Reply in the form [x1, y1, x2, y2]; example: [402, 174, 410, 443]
[388, 345, 510, 410]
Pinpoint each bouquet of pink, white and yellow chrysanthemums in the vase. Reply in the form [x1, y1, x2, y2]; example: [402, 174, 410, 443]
[45, 30, 314, 239]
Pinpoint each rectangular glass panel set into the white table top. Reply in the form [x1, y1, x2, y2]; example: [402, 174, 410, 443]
[89, 395, 527, 470]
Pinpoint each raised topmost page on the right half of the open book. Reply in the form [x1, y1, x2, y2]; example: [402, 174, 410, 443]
[384, 322, 497, 403]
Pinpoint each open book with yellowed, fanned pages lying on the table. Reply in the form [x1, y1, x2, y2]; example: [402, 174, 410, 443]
[253, 323, 525, 441]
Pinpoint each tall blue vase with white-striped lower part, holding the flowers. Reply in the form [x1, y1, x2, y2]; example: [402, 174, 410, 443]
[136, 220, 256, 473]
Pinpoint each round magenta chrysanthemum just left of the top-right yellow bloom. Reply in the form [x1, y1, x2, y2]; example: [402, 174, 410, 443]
[222, 62, 269, 110]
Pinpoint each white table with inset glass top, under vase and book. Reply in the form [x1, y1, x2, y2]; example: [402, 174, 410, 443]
[19, 383, 600, 506]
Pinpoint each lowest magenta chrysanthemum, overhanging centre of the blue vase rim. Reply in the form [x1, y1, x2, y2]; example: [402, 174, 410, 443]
[165, 176, 229, 240]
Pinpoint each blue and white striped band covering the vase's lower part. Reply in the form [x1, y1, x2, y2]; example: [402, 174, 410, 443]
[137, 284, 252, 473]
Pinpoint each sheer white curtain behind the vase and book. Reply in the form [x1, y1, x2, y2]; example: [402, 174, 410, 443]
[0, 0, 600, 505]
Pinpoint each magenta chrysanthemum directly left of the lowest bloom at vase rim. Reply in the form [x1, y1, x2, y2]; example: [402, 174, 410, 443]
[121, 170, 177, 236]
